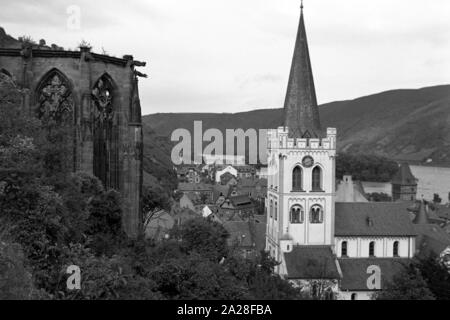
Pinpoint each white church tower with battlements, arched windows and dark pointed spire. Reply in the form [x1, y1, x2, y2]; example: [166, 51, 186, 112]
[266, 1, 336, 274]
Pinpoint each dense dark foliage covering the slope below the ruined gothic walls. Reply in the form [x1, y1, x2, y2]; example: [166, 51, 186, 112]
[0, 87, 301, 299]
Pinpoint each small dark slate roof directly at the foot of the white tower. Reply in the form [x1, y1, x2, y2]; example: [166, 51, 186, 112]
[284, 246, 341, 279]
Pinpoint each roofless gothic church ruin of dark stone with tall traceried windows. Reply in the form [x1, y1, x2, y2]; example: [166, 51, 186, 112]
[0, 28, 145, 237]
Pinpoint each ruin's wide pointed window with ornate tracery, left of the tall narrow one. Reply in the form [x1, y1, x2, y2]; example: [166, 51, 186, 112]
[36, 69, 75, 124]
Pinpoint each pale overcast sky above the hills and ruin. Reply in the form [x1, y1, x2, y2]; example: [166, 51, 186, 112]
[0, 0, 450, 114]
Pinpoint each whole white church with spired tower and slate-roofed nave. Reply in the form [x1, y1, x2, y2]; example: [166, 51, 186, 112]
[266, 6, 450, 300]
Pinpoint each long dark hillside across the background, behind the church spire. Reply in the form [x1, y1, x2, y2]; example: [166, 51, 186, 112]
[143, 85, 450, 165]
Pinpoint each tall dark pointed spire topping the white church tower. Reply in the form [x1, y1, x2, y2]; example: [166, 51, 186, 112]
[284, 1, 322, 138]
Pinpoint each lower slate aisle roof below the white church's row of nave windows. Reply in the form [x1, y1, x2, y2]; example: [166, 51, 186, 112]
[339, 258, 410, 291]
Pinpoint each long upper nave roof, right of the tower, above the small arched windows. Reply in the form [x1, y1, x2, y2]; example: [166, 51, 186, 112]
[335, 202, 416, 236]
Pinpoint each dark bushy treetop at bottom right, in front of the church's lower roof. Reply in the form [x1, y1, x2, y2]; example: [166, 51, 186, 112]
[374, 263, 435, 300]
